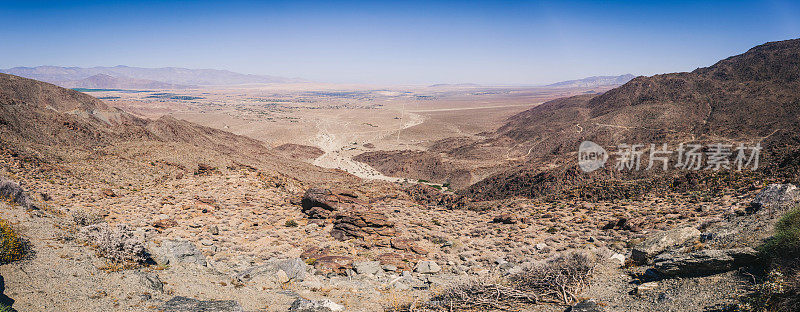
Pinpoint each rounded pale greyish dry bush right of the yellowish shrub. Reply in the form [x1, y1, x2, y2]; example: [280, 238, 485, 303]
[78, 223, 148, 265]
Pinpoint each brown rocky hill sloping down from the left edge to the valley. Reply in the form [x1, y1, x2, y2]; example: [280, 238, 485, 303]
[0, 74, 355, 183]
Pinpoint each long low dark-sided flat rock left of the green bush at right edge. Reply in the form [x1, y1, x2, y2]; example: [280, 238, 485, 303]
[653, 247, 758, 277]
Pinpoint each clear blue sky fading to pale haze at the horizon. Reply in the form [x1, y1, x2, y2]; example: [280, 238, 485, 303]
[0, 0, 800, 84]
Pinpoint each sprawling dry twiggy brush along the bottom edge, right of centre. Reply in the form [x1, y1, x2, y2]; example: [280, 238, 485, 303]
[394, 251, 595, 311]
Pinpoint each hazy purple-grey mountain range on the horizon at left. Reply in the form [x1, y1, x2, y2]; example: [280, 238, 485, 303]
[0, 65, 304, 89]
